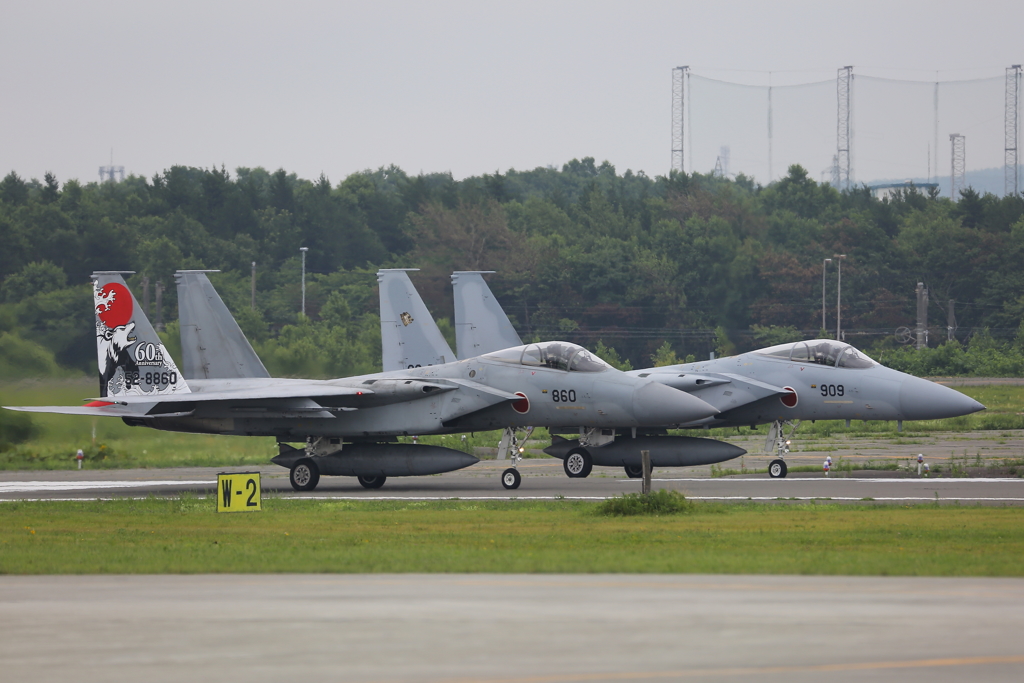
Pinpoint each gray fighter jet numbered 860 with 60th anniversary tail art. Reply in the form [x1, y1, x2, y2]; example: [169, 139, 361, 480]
[4, 271, 717, 490]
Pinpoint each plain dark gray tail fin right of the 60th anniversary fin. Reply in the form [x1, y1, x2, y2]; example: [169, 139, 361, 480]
[174, 270, 270, 380]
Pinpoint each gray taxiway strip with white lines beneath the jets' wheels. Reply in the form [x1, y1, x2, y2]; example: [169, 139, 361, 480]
[0, 460, 1024, 506]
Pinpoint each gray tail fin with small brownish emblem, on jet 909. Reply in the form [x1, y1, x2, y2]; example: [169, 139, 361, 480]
[377, 268, 456, 373]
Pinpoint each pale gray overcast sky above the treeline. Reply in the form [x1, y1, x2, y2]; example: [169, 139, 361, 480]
[0, 0, 1024, 187]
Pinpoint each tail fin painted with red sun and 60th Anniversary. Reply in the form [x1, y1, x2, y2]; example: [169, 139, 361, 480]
[92, 270, 188, 396]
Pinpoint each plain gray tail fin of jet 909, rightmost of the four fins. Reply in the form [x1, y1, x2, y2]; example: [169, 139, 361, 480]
[452, 270, 522, 359]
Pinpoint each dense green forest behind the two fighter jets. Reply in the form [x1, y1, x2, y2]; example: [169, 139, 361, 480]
[0, 158, 1024, 378]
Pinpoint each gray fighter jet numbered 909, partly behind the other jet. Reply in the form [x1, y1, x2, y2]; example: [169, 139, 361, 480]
[440, 271, 985, 478]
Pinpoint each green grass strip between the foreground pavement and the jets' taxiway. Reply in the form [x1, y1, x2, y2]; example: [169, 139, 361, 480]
[0, 496, 1024, 577]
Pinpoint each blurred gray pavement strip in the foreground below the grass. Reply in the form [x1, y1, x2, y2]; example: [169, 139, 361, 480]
[0, 574, 1024, 683]
